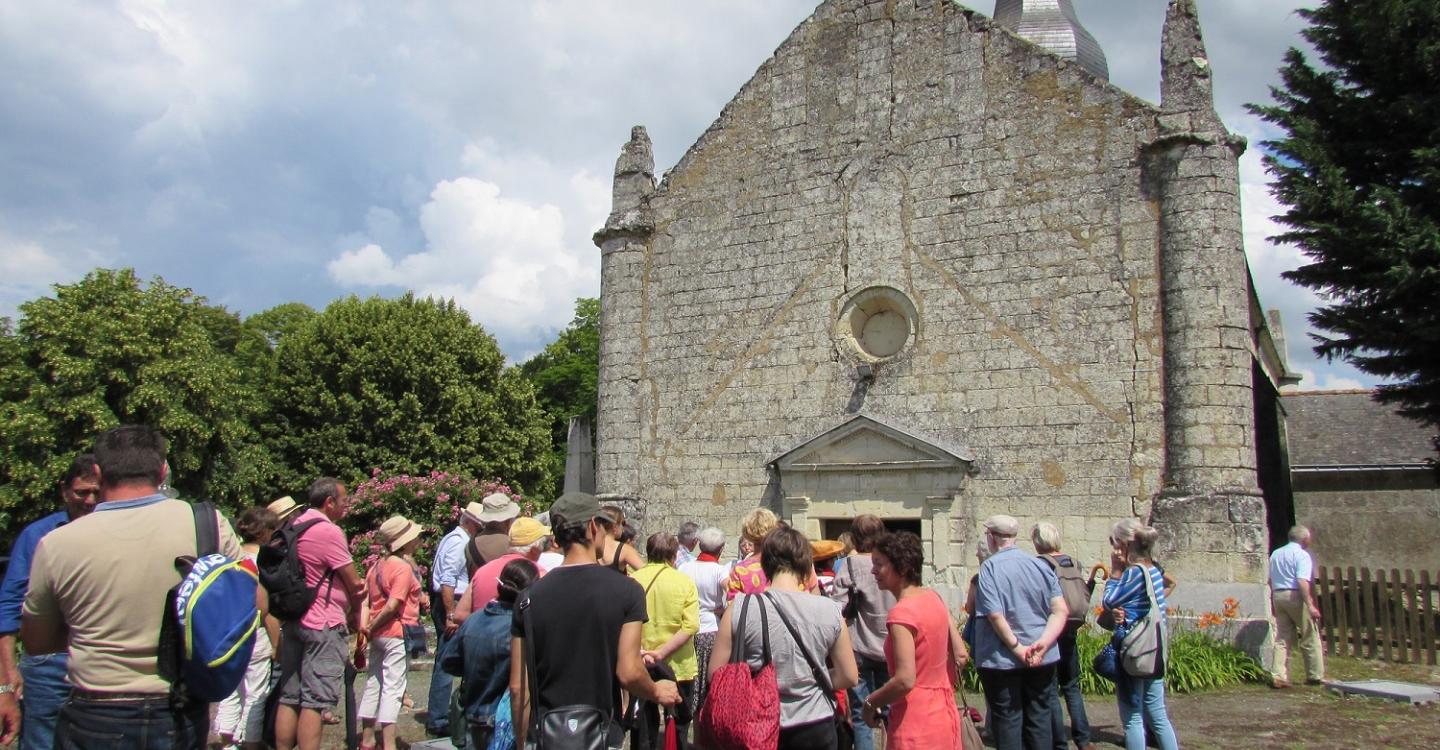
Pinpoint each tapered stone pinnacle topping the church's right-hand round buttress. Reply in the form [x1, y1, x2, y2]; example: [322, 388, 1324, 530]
[1161, 0, 1225, 132]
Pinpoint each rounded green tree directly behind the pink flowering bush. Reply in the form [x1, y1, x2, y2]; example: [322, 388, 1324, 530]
[266, 295, 554, 495]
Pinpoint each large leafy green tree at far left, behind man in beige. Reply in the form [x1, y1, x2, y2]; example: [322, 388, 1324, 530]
[0, 269, 274, 528]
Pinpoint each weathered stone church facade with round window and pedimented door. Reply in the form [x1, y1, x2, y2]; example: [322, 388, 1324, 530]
[596, 0, 1284, 615]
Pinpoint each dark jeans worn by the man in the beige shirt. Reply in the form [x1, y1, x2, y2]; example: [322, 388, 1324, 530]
[55, 697, 210, 750]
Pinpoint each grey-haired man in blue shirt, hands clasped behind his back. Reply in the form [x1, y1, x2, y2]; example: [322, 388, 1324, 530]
[975, 515, 1068, 750]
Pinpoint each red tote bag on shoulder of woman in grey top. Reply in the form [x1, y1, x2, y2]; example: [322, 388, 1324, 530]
[696, 596, 780, 750]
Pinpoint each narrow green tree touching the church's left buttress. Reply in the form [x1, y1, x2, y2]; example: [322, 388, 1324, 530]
[520, 297, 600, 472]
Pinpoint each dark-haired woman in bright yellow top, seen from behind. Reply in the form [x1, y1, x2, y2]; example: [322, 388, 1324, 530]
[631, 531, 700, 750]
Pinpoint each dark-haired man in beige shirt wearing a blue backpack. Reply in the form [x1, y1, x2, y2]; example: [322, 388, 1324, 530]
[20, 425, 242, 750]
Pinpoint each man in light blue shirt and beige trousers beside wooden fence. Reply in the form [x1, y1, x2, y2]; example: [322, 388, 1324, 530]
[1270, 525, 1325, 688]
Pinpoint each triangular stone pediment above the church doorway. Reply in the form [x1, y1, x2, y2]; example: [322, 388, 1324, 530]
[770, 415, 972, 472]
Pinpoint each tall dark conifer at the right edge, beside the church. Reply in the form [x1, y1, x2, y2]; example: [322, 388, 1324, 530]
[1250, 0, 1440, 443]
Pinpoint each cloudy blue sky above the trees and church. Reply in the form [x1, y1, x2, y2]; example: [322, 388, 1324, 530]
[0, 0, 1374, 389]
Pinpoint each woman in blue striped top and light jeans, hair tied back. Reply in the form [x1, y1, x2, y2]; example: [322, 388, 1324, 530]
[1104, 518, 1179, 750]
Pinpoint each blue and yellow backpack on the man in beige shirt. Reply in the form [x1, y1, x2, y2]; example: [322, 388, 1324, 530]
[158, 502, 261, 702]
